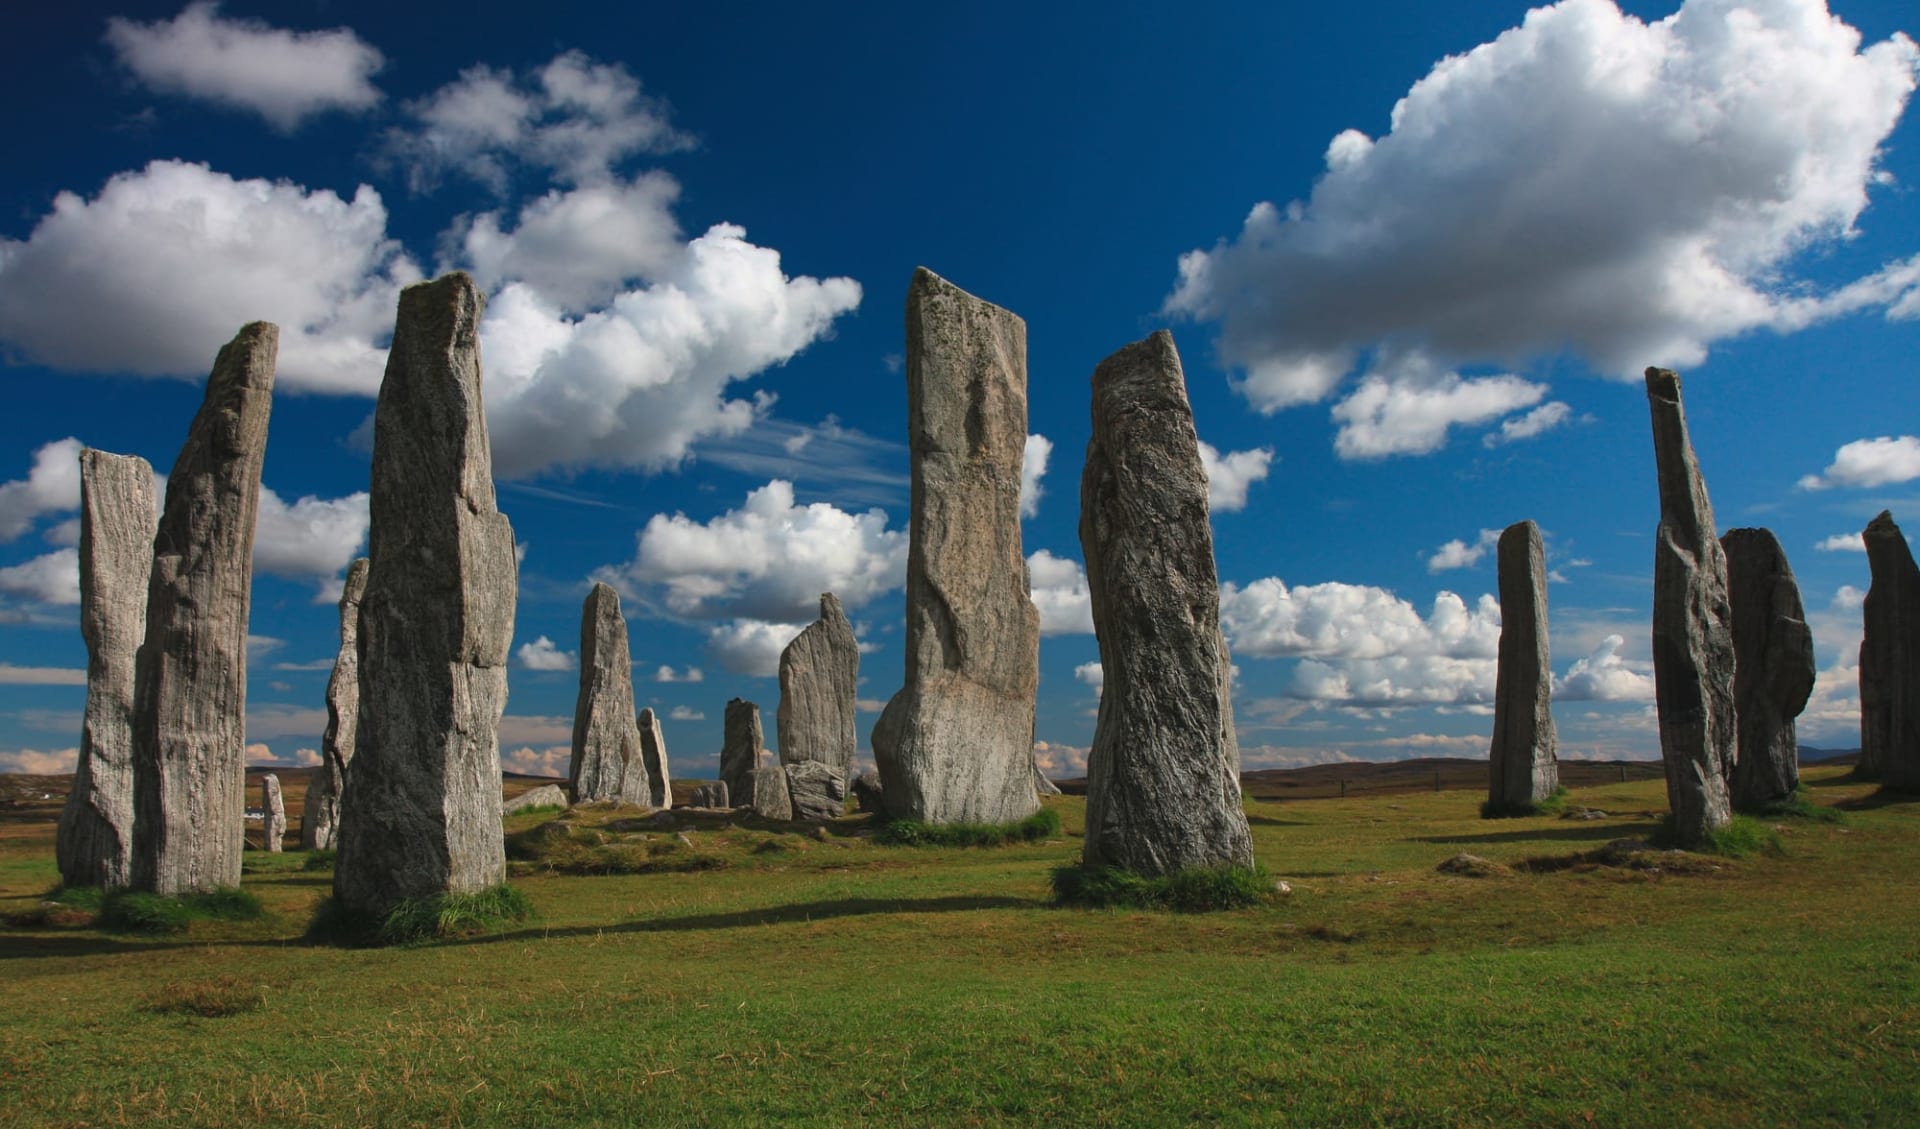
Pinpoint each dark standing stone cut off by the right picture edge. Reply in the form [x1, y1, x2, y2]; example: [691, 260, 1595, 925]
[1859, 511, 1920, 791]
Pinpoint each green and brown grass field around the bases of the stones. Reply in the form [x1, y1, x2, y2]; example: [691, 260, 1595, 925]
[0, 768, 1920, 1127]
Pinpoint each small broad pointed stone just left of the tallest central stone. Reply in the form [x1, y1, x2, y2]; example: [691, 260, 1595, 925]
[776, 591, 860, 780]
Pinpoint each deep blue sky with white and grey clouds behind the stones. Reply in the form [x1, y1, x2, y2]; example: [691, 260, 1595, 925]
[0, 0, 1920, 776]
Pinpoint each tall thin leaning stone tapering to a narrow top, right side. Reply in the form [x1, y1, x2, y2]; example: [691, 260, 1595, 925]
[1647, 369, 1740, 847]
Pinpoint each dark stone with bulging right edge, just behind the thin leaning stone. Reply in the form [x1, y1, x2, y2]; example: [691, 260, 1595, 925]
[1720, 530, 1814, 812]
